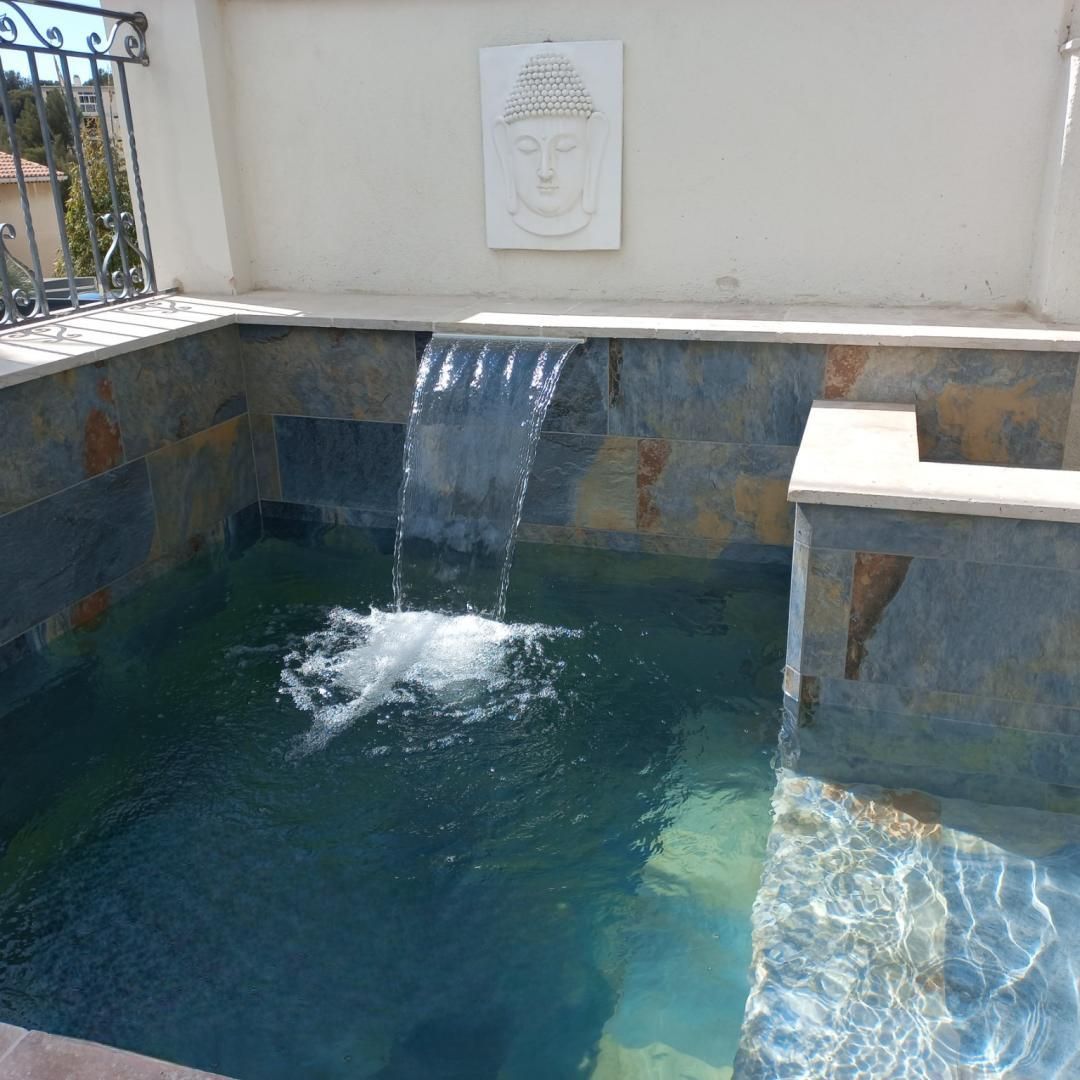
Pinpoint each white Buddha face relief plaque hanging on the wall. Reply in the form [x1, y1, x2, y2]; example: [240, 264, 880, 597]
[480, 41, 622, 251]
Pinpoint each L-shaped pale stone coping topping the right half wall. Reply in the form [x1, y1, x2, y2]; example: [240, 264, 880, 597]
[787, 401, 1080, 523]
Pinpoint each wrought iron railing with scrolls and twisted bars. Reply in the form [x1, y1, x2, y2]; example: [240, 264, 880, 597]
[0, 0, 156, 327]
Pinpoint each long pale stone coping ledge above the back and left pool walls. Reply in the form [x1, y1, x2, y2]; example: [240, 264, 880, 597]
[0, 291, 1080, 387]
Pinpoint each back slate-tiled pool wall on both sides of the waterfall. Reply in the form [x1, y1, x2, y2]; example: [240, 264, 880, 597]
[241, 326, 1077, 561]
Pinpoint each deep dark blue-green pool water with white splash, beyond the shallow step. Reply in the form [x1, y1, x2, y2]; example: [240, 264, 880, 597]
[0, 540, 787, 1080]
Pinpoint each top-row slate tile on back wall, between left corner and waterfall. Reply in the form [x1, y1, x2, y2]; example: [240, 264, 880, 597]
[241, 326, 417, 423]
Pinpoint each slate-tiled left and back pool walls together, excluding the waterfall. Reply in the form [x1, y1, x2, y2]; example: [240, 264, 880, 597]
[6, 325, 1077, 663]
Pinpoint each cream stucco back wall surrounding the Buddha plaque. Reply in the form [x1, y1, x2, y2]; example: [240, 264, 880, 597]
[130, 0, 1080, 314]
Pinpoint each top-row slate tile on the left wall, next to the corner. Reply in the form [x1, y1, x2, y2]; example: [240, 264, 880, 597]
[108, 326, 247, 458]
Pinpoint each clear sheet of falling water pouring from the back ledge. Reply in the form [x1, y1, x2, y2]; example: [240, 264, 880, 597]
[394, 335, 580, 619]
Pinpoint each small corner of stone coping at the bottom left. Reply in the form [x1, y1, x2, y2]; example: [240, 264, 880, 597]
[0, 1024, 227, 1080]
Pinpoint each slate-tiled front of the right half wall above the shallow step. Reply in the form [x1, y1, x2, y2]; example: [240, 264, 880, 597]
[784, 505, 1080, 810]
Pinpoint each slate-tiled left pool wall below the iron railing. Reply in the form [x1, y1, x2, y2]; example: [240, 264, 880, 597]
[0, 326, 259, 669]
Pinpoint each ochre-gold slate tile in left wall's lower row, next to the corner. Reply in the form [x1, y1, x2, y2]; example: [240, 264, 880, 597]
[147, 416, 258, 552]
